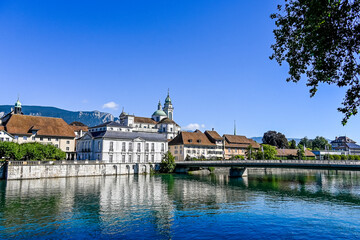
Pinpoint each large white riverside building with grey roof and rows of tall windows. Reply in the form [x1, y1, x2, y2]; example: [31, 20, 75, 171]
[76, 122, 168, 163]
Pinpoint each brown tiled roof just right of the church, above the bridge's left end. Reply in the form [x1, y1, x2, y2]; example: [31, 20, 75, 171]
[169, 130, 215, 146]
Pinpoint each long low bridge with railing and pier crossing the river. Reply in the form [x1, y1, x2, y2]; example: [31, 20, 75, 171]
[175, 160, 360, 177]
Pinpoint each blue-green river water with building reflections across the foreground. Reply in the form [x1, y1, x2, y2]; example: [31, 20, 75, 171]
[0, 169, 360, 239]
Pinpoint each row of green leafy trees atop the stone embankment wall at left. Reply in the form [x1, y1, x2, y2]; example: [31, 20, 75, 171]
[0, 142, 66, 161]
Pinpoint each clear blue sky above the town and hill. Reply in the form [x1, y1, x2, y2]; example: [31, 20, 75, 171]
[0, 0, 360, 141]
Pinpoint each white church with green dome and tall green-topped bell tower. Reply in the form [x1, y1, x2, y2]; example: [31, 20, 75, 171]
[119, 90, 181, 139]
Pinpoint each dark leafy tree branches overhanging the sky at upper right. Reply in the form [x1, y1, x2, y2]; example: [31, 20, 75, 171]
[270, 0, 360, 125]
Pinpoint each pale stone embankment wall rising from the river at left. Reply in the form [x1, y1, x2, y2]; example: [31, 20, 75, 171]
[4, 161, 159, 180]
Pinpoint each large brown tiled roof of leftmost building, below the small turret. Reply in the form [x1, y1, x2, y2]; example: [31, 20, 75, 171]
[4, 114, 75, 137]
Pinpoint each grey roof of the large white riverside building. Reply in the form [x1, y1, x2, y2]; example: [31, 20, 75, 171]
[89, 131, 167, 142]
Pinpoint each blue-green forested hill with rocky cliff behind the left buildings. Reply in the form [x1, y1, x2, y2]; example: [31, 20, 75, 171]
[0, 105, 117, 126]
